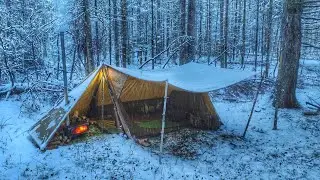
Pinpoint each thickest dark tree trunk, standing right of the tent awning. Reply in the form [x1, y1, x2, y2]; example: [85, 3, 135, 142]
[276, 0, 302, 108]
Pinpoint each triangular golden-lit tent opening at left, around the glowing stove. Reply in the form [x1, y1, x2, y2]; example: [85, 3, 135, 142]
[47, 71, 119, 149]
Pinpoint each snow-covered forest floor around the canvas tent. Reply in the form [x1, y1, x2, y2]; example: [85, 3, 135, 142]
[0, 61, 320, 179]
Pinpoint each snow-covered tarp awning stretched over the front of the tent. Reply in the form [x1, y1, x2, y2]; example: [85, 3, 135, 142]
[112, 63, 255, 93]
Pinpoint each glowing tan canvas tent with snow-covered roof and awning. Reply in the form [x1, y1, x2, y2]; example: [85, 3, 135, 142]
[29, 63, 253, 150]
